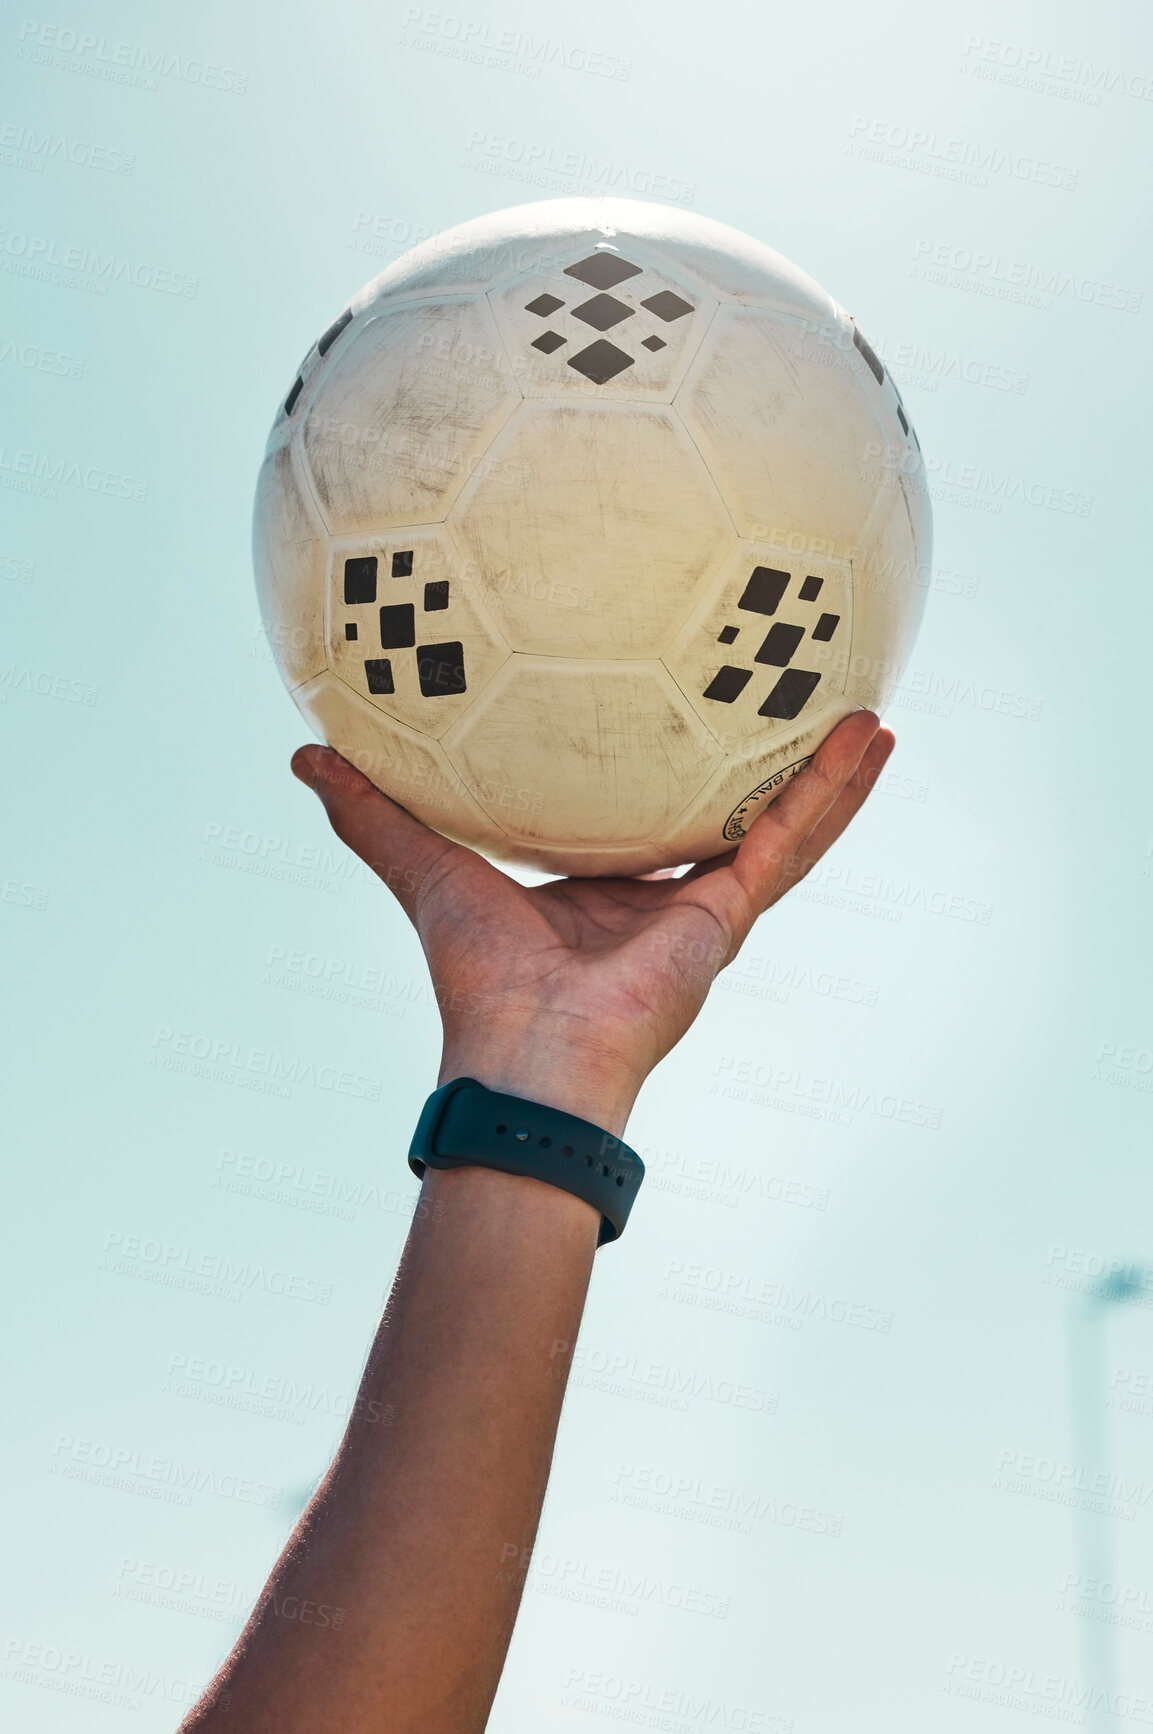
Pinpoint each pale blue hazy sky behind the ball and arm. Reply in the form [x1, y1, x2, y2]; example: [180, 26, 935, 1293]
[0, 0, 1153, 1734]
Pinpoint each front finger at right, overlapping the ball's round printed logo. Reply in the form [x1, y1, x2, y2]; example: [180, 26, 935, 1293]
[733, 711, 881, 916]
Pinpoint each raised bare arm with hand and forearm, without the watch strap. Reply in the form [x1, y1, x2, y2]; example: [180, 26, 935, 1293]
[184, 713, 893, 1734]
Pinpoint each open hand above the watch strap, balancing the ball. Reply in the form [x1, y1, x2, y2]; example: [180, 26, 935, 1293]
[293, 711, 893, 1136]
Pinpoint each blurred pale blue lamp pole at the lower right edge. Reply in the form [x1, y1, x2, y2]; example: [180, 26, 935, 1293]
[1068, 1264, 1143, 1734]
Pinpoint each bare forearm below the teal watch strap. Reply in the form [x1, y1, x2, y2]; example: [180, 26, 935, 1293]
[186, 1167, 598, 1734]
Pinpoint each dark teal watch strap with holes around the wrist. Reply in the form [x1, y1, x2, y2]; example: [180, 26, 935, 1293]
[409, 1079, 645, 1247]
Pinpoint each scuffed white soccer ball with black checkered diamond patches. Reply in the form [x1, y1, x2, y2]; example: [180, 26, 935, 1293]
[255, 198, 929, 874]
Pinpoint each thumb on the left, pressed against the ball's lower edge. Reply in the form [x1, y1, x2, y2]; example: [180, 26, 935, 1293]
[293, 746, 465, 916]
